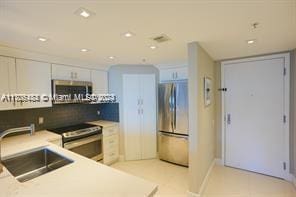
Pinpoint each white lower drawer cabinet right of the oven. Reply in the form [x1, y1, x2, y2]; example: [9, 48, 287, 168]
[103, 125, 119, 165]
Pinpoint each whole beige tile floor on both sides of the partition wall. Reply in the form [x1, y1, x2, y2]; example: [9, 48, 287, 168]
[111, 159, 296, 197]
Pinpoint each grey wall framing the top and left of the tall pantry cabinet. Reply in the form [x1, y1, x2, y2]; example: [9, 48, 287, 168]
[108, 65, 159, 155]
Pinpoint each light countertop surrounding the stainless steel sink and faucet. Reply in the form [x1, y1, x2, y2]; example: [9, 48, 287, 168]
[0, 131, 157, 197]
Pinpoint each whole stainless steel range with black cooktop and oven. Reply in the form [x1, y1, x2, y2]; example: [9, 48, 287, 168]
[49, 123, 103, 161]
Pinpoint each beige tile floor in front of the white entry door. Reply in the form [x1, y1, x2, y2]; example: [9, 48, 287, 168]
[203, 166, 296, 197]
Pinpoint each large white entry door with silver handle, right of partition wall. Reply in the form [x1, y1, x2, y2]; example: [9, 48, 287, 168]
[223, 58, 285, 178]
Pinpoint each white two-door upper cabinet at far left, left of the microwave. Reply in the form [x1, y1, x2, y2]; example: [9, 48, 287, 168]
[0, 56, 52, 110]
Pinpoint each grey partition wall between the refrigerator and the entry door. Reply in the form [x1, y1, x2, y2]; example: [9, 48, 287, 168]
[188, 42, 217, 194]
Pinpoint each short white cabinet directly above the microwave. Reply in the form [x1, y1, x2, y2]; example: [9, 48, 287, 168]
[52, 64, 91, 81]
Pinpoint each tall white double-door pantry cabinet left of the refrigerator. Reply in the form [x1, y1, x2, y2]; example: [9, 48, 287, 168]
[123, 74, 156, 160]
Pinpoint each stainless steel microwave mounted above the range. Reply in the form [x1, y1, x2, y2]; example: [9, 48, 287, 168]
[52, 80, 92, 104]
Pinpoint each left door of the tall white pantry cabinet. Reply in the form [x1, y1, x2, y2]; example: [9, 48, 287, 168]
[122, 74, 141, 160]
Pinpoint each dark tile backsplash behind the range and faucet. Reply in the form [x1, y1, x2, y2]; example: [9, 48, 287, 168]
[0, 103, 119, 133]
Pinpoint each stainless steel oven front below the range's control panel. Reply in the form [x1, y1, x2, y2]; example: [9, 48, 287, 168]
[64, 134, 103, 161]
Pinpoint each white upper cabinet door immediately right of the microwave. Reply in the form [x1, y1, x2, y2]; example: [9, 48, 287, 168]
[91, 70, 108, 94]
